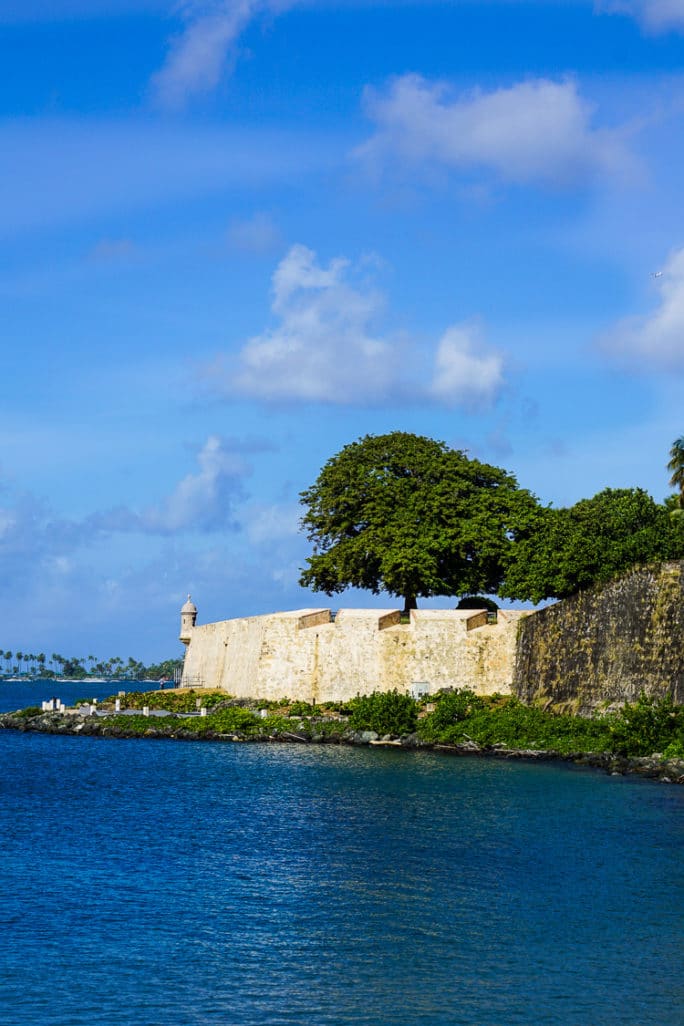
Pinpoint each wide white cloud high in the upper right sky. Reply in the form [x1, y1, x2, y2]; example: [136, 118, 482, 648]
[358, 75, 627, 186]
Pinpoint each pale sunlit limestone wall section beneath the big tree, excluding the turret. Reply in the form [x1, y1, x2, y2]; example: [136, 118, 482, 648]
[183, 609, 525, 702]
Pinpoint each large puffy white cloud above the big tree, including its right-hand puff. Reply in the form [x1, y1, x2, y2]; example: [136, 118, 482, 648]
[210, 245, 502, 406]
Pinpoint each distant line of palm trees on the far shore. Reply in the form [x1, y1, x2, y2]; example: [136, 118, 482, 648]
[0, 648, 183, 680]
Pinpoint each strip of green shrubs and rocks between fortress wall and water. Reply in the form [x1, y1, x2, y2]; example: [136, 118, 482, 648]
[0, 688, 684, 784]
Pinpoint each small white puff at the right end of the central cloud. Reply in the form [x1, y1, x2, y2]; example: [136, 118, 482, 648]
[432, 324, 504, 406]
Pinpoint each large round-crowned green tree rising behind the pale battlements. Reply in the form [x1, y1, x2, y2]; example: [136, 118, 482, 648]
[299, 431, 538, 610]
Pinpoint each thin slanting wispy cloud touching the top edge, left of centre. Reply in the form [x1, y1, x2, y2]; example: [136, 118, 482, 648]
[152, 0, 297, 108]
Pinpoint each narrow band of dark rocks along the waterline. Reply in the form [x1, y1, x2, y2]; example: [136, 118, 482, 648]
[0, 710, 684, 784]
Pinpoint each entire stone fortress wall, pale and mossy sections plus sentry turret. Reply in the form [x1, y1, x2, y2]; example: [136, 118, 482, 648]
[180, 561, 684, 714]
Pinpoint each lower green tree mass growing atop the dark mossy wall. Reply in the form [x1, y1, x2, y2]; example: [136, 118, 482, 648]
[500, 488, 684, 602]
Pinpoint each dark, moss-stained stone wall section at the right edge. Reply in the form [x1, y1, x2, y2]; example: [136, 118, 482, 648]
[513, 561, 684, 714]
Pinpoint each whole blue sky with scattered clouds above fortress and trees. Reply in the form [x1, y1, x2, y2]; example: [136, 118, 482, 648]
[0, 0, 684, 660]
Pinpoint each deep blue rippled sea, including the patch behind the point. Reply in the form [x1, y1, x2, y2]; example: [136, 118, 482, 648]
[0, 683, 684, 1026]
